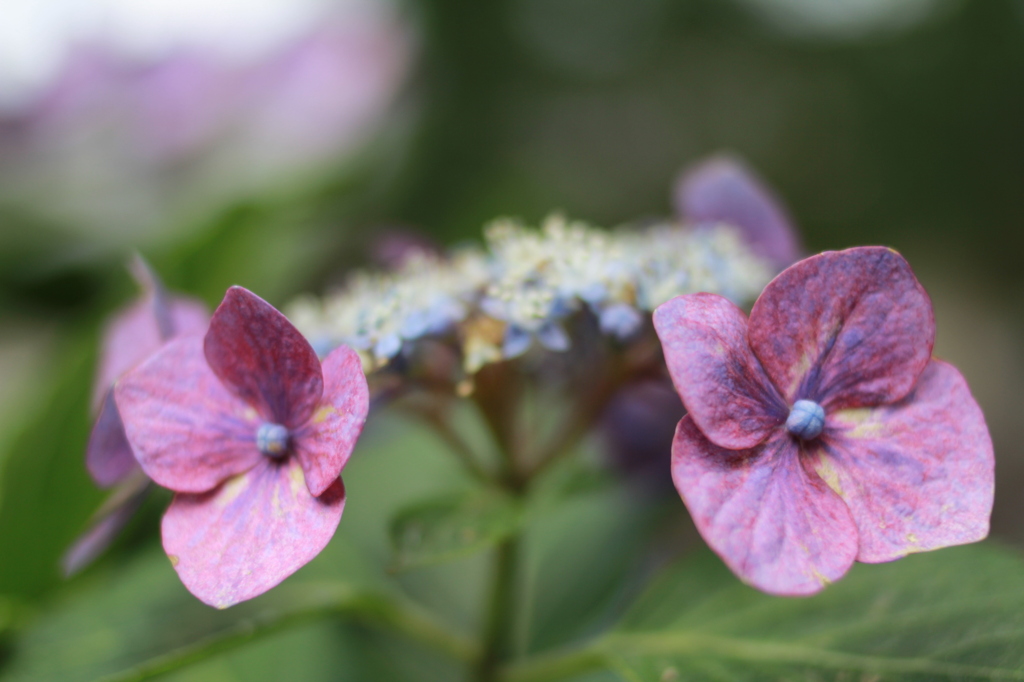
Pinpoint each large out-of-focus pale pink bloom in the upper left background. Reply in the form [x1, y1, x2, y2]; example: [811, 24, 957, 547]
[0, 1, 413, 245]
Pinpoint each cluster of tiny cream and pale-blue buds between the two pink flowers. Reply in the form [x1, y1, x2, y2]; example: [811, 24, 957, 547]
[288, 215, 773, 374]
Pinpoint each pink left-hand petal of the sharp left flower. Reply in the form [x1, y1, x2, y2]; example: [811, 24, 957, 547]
[114, 336, 263, 493]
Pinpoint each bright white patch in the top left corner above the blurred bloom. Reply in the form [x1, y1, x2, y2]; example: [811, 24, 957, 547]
[0, 0, 344, 110]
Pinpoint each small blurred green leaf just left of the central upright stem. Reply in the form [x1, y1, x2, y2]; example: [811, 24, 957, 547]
[390, 488, 523, 570]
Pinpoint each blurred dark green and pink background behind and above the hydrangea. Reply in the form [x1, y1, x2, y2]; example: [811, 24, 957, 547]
[0, 0, 1024, 679]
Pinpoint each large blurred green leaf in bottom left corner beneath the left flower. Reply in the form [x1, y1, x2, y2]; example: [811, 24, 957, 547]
[4, 535, 471, 682]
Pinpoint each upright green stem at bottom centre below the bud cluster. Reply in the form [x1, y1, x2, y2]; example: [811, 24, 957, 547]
[475, 538, 519, 682]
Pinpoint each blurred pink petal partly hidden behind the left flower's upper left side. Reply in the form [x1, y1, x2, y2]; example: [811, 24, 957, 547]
[92, 292, 210, 410]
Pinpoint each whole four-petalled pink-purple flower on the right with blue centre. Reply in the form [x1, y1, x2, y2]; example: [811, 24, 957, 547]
[654, 247, 994, 595]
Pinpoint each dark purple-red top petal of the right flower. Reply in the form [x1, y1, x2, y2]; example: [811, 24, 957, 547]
[748, 247, 935, 412]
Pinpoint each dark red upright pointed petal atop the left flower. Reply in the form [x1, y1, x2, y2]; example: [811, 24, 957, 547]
[206, 287, 324, 428]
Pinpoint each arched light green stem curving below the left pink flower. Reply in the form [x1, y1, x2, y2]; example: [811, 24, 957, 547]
[96, 586, 479, 682]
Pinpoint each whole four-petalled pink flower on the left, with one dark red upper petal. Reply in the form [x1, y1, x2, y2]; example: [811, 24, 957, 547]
[115, 287, 369, 608]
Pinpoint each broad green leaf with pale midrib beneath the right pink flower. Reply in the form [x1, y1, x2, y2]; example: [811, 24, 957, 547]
[505, 545, 1024, 682]
